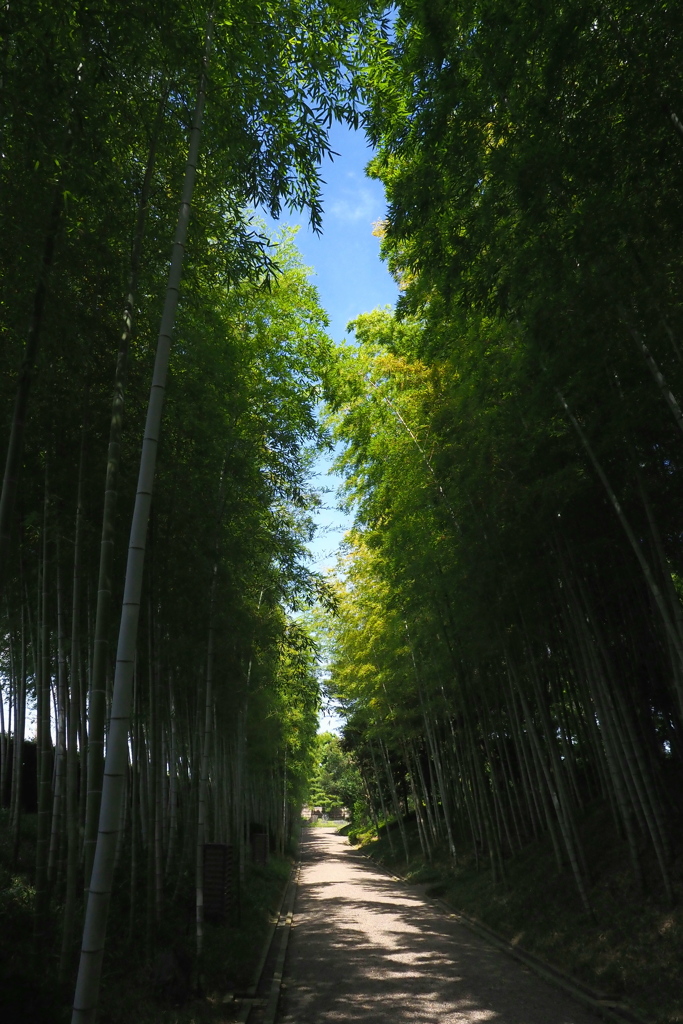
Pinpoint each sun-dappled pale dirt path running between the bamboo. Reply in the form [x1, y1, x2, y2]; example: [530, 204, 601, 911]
[279, 828, 598, 1024]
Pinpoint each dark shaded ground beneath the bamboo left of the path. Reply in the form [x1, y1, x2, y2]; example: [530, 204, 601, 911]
[0, 812, 292, 1024]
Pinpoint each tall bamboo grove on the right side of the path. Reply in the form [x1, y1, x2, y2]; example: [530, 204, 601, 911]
[329, 0, 683, 914]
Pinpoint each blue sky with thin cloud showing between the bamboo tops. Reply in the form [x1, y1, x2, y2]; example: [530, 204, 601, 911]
[272, 119, 398, 730]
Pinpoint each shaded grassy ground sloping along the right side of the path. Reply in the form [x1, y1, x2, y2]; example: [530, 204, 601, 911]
[350, 807, 683, 1024]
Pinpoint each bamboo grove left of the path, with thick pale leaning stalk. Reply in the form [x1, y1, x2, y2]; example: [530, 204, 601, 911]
[0, 0, 385, 1021]
